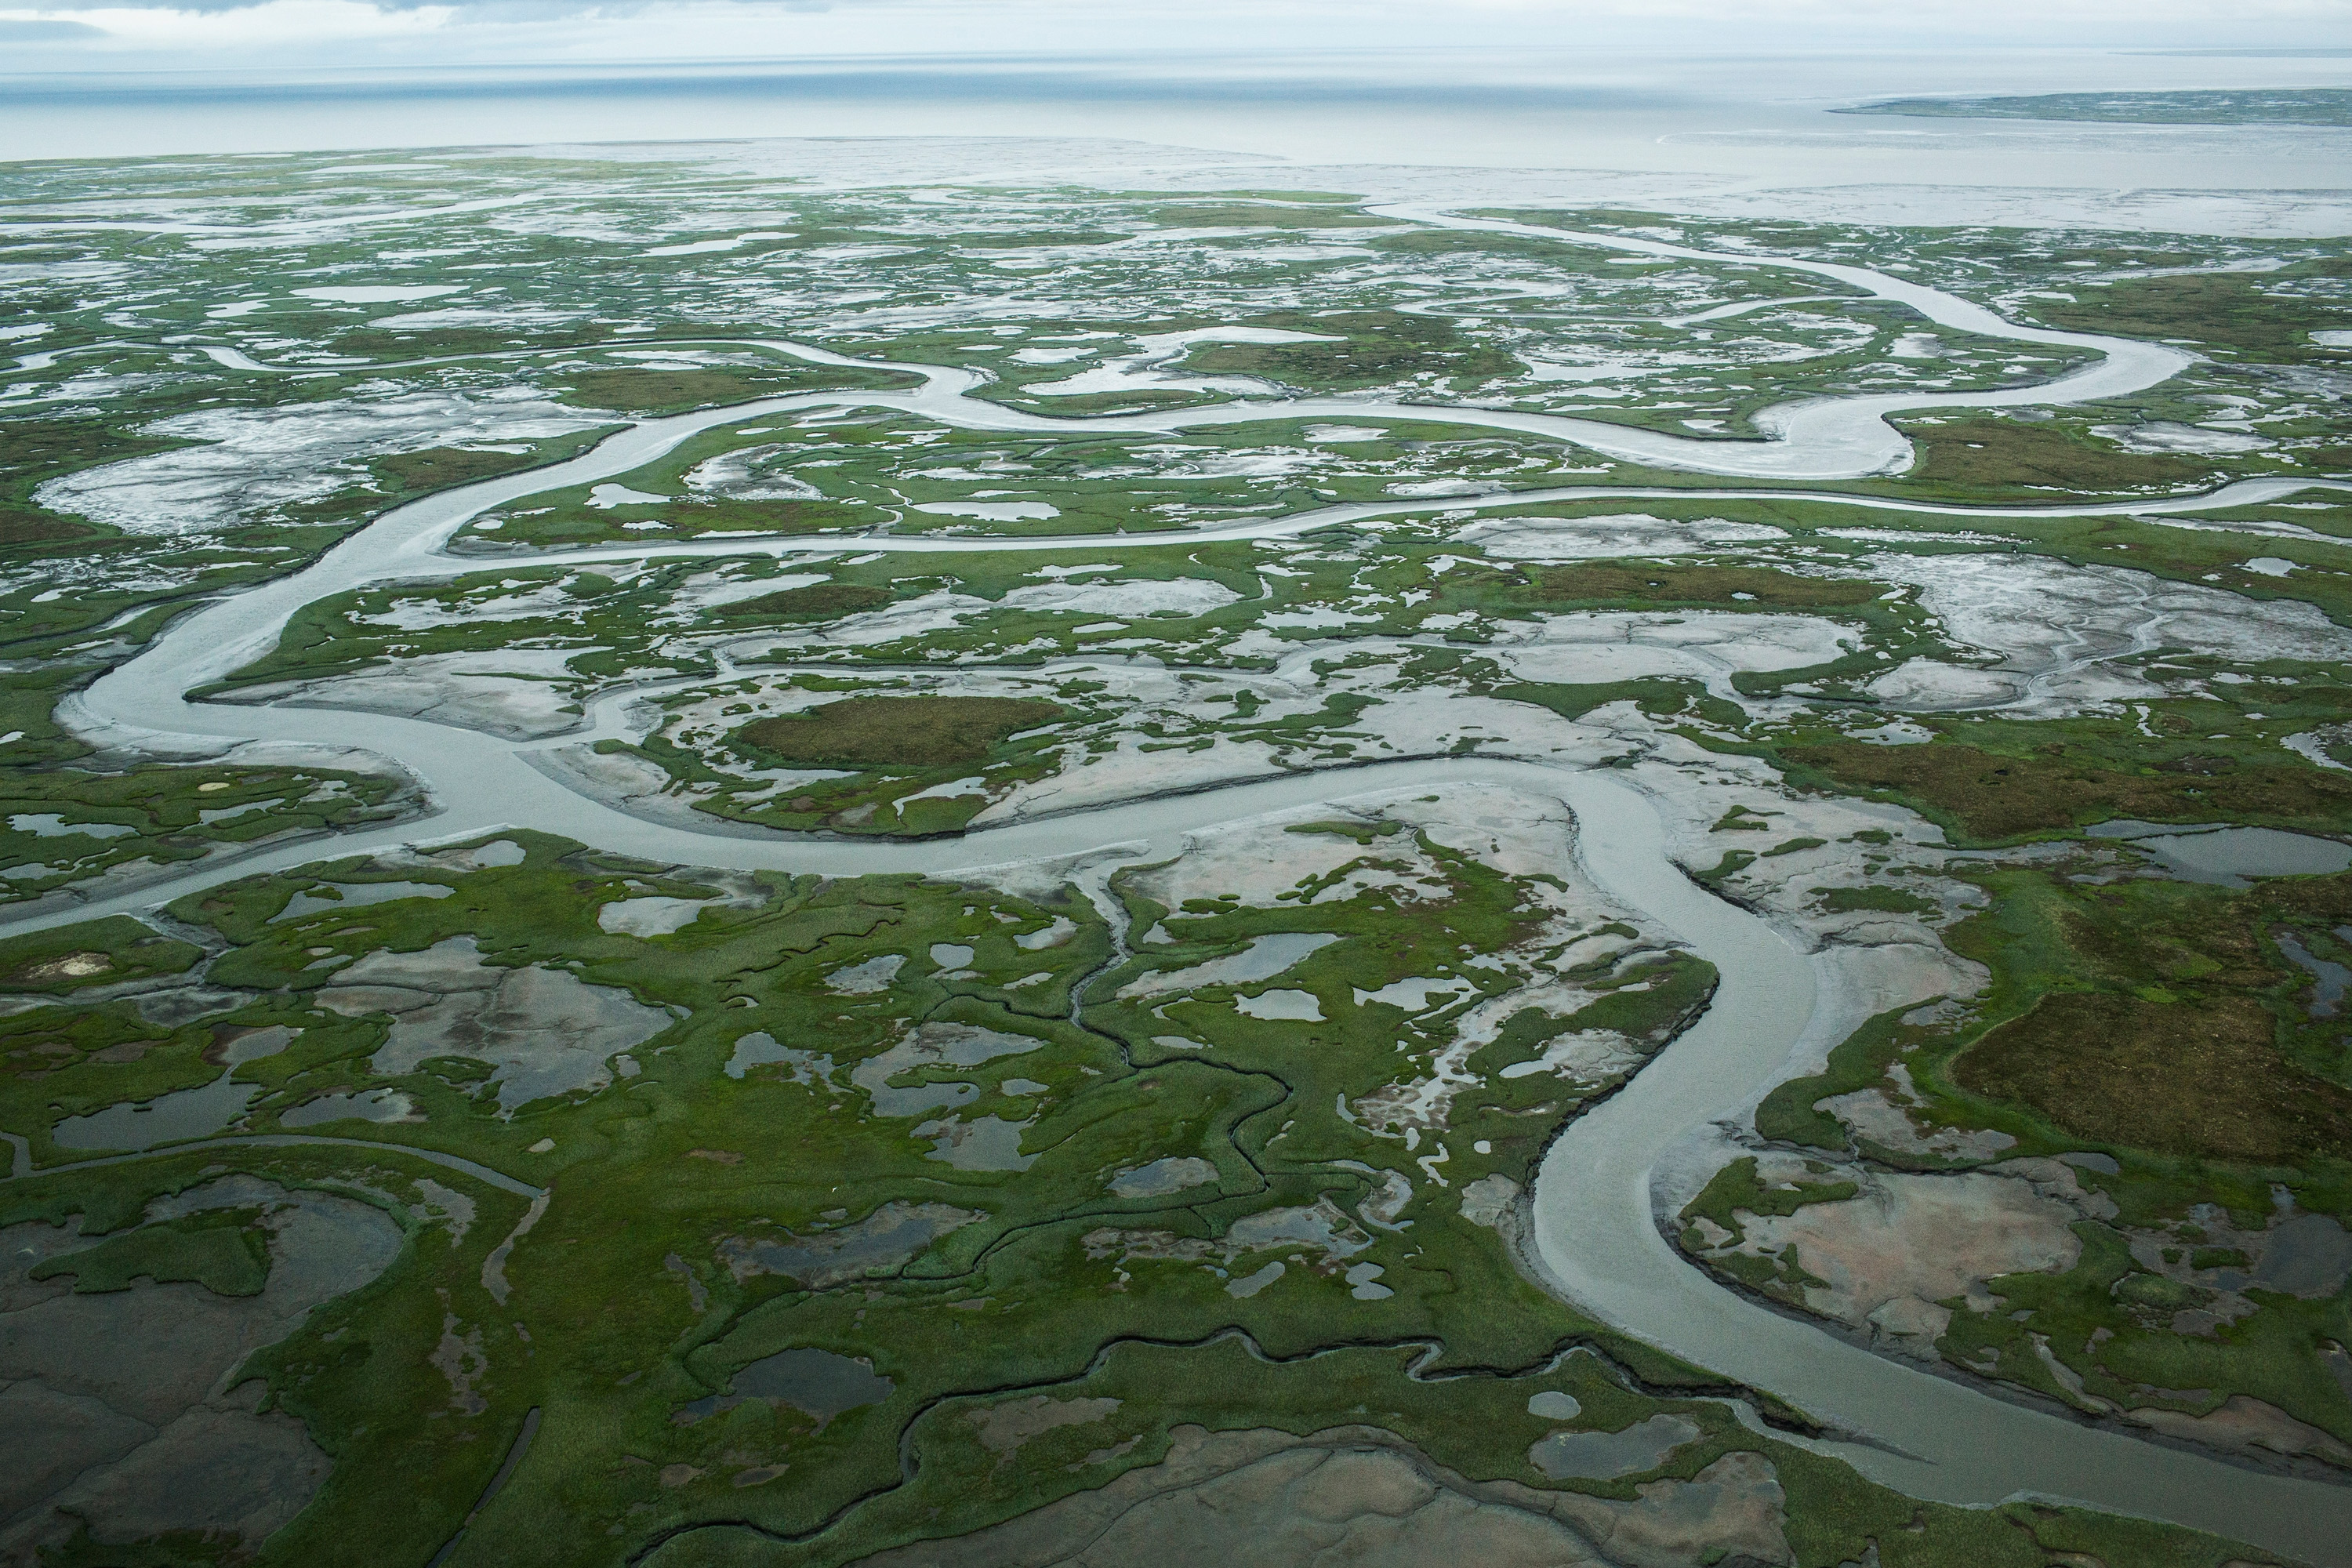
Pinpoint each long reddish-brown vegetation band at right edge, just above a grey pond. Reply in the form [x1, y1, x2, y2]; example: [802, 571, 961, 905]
[1785, 741, 2352, 839]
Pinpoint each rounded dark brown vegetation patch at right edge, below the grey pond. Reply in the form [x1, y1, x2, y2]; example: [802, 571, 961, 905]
[1952, 992, 2352, 1163]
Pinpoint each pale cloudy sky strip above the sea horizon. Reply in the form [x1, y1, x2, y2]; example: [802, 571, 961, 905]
[13, 0, 2352, 75]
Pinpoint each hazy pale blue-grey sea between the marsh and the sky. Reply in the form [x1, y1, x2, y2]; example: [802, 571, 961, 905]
[13, 49, 2352, 230]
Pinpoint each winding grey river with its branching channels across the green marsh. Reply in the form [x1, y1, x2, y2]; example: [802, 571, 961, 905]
[18, 209, 2352, 1563]
